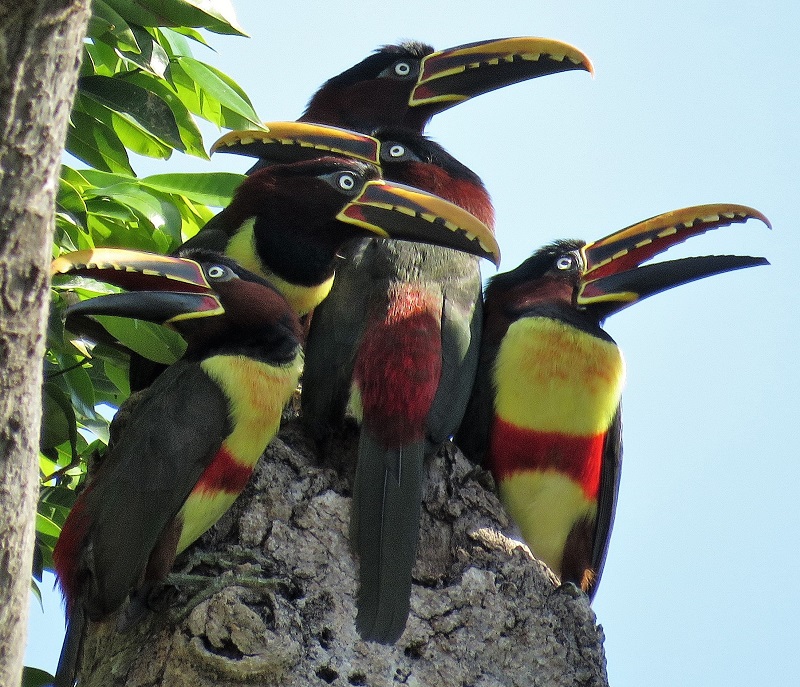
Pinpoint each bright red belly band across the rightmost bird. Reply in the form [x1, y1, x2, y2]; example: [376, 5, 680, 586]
[490, 416, 606, 499]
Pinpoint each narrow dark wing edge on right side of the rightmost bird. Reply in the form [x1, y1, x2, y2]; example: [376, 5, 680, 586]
[588, 405, 622, 599]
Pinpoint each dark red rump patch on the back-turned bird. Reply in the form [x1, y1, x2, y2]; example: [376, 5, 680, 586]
[354, 284, 442, 448]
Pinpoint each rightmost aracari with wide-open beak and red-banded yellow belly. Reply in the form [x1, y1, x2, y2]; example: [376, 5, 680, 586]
[456, 204, 769, 599]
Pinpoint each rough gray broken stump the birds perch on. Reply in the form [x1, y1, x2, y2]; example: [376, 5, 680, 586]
[80, 422, 607, 687]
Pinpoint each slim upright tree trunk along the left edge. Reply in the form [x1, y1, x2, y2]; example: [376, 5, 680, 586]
[0, 0, 90, 686]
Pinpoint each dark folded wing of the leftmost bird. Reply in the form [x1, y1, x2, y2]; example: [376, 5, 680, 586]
[84, 361, 230, 617]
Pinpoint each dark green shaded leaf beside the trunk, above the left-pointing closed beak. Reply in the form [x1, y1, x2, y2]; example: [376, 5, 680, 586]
[78, 76, 184, 150]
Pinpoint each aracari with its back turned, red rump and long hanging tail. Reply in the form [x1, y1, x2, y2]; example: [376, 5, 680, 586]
[214, 122, 494, 642]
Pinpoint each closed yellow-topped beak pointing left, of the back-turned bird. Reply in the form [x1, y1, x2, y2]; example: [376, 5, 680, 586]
[211, 122, 380, 165]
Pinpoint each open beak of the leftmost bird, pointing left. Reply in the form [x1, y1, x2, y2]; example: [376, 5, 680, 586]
[51, 248, 225, 324]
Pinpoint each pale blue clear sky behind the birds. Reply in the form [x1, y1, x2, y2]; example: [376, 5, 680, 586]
[27, 0, 800, 687]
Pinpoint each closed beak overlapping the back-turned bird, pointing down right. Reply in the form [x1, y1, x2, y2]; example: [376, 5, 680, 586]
[336, 179, 500, 265]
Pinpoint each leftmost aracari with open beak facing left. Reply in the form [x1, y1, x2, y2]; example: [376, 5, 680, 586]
[53, 249, 303, 687]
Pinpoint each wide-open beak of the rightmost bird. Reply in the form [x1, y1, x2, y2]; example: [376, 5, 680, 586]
[576, 203, 772, 319]
